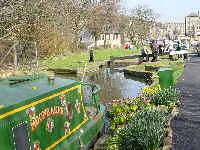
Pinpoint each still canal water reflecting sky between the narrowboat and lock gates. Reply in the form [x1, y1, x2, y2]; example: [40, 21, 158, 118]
[59, 68, 148, 104]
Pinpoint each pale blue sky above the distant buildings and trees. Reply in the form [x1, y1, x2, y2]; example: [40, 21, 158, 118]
[122, 0, 200, 23]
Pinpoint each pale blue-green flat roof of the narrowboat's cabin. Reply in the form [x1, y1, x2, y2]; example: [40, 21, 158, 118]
[0, 76, 76, 108]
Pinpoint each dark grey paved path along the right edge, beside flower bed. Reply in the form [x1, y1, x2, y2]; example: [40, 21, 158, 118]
[171, 56, 200, 150]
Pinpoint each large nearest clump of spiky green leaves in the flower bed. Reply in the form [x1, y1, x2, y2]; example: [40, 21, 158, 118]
[118, 107, 166, 150]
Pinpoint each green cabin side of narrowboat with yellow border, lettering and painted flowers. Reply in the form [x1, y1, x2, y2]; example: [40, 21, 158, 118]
[0, 84, 88, 150]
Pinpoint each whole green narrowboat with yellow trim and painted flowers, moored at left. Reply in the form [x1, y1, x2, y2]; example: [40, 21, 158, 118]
[0, 75, 105, 150]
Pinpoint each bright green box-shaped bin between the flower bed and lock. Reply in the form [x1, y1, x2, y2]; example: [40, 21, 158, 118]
[158, 68, 174, 89]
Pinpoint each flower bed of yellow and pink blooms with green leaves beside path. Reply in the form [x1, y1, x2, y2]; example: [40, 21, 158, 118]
[105, 85, 180, 150]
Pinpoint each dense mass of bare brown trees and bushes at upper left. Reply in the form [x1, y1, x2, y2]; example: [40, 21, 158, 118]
[0, 0, 122, 55]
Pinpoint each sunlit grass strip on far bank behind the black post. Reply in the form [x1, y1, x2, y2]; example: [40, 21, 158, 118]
[40, 48, 139, 69]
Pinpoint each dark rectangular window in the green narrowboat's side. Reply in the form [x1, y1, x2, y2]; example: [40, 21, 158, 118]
[13, 123, 30, 150]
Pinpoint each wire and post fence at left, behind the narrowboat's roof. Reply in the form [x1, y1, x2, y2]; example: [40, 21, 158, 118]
[0, 40, 38, 72]
